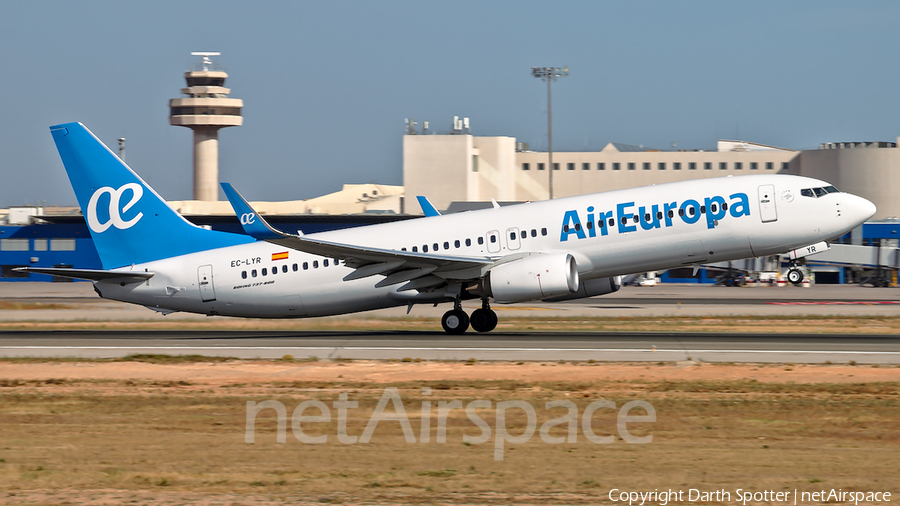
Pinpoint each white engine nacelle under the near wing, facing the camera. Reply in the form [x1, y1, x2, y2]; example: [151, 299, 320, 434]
[485, 253, 579, 303]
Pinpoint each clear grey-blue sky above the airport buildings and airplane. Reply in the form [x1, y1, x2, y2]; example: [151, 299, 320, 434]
[0, 0, 900, 206]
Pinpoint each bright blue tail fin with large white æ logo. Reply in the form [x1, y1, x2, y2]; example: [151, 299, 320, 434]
[50, 123, 253, 269]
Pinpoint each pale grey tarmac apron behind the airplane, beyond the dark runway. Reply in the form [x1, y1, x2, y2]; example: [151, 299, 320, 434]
[0, 282, 900, 322]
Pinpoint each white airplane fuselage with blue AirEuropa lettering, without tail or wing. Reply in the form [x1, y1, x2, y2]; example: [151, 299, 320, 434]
[96, 175, 874, 317]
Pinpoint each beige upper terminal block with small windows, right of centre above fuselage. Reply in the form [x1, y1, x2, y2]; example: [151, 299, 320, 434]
[403, 123, 900, 220]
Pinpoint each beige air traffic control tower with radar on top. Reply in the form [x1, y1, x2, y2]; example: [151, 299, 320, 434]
[169, 52, 244, 201]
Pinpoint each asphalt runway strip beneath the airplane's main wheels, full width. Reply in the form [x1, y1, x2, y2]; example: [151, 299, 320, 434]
[0, 331, 900, 364]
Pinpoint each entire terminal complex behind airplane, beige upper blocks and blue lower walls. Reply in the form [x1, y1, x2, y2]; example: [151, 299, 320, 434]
[0, 120, 900, 282]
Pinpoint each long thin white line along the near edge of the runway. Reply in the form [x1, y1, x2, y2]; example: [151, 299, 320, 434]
[0, 346, 900, 355]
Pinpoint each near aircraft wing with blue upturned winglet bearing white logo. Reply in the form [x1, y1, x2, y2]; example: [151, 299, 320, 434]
[222, 183, 500, 286]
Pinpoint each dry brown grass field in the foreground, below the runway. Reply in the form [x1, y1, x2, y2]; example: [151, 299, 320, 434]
[0, 357, 900, 505]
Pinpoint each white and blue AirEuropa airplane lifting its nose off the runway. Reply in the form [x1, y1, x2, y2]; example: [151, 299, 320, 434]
[22, 123, 875, 334]
